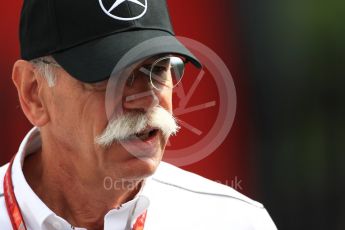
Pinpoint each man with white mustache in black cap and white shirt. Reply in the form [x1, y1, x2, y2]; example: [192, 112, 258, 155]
[0, 0, 276, 230]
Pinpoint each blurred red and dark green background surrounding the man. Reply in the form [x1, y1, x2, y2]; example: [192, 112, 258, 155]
[0, 0, 345, 230]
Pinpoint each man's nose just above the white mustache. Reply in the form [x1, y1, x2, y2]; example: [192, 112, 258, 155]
[123, 74, 159, 111]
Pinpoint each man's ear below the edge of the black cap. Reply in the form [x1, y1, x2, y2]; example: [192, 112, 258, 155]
[12, 60, 49, 127]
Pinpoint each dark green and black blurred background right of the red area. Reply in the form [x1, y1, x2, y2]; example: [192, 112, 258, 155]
[235, 0, 345, 230]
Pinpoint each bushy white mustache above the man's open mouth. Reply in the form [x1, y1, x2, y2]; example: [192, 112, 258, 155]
[95, 106, 180, 147]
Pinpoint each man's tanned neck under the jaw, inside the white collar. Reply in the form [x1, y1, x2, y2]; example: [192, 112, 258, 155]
[23, 148, 141, 229]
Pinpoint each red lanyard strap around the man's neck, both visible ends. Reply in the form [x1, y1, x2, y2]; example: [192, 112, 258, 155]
[4, 158, 147, 230]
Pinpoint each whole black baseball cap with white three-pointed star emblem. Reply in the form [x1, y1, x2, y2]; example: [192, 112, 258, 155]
[20, 0, 201, 83]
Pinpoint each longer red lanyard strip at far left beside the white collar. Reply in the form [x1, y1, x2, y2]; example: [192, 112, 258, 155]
[4, 158, 26, 230]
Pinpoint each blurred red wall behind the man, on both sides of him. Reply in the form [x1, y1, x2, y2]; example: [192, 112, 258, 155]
[0, 0, 256, 198]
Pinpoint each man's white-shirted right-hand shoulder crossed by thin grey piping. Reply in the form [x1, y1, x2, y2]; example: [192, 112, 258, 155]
[144, 162, 276, 230]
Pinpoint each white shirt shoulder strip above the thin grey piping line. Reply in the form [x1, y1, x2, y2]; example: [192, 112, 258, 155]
[152, 162, 263, 208]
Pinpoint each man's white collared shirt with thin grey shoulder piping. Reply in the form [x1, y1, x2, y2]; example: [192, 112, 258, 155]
[0, 128, 276, 230]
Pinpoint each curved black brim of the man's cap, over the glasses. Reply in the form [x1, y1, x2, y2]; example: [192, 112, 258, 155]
[52, 29, 202, 83]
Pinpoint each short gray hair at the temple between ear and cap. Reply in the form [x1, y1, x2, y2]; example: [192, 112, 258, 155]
[30, 56, 61, 87]
